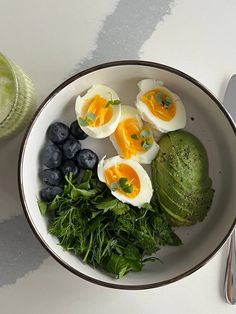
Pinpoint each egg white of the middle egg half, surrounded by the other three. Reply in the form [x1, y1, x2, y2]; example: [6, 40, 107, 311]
[110, 105, 159, 164]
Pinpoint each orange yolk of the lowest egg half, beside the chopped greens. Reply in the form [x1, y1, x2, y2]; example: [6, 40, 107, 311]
[104, 163, 140, 198]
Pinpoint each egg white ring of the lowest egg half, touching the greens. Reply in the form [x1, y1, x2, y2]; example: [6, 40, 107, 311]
[97, 156, 153, 207]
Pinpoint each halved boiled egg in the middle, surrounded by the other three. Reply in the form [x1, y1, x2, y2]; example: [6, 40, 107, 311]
[110, 105, 159, 164]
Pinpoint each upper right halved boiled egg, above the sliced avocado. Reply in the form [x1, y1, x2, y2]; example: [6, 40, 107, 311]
[136, 79, 186, 133]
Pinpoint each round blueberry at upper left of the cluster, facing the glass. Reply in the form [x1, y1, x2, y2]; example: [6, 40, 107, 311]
[47, 122, 70, 144]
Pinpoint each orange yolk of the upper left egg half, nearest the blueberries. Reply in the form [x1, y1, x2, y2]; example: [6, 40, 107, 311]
[83, 95, 113, 127]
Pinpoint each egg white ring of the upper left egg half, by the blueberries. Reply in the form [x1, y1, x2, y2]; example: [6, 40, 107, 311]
[75, 84, 121, 138]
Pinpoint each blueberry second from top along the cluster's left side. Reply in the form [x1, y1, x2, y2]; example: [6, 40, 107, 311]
[42, 144, 62, 168]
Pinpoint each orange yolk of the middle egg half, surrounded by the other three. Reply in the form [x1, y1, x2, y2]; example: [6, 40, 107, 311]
[114, 118, 153, 159]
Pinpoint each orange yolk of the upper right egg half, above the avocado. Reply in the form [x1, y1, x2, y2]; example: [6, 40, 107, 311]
[140, 88, 176, 121]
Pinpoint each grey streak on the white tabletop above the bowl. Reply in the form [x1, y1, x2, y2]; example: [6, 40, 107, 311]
[71, 0, 174, 74]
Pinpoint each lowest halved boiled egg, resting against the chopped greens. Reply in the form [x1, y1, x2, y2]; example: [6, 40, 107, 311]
[97, 156, 153, 207]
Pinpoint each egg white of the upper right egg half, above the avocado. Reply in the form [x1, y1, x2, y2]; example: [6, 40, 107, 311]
[135, 79, 186, 133]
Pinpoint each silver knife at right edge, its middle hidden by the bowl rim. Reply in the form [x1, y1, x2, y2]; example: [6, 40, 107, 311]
[224, 74, 236, 304]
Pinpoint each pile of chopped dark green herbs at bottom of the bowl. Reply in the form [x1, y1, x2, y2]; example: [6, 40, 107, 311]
[38, 170, 181, 278]
